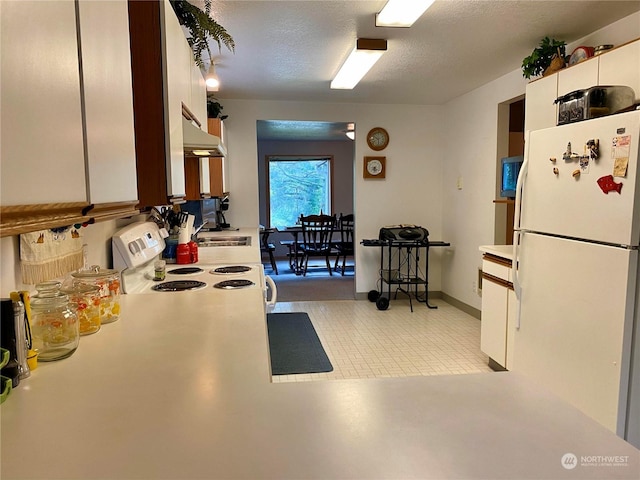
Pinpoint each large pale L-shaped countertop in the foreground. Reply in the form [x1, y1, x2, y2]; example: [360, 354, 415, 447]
[0, 231, 640, 479]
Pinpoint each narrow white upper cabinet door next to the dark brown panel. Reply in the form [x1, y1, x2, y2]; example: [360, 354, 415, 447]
[78, 0, 138, 204]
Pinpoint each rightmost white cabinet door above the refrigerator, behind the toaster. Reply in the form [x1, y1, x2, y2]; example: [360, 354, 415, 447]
[598, 40, 640, 100]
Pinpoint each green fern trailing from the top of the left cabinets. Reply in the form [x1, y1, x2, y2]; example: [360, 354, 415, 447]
[170, 0, 236, 67]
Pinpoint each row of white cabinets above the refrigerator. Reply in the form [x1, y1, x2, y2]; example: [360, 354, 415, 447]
[525, 40, 640, 130]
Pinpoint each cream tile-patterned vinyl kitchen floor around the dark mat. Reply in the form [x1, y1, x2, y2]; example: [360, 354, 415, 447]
[272, 299, 492, 383]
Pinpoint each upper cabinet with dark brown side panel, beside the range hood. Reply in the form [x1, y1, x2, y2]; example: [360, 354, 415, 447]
[129, 0, 193, 207]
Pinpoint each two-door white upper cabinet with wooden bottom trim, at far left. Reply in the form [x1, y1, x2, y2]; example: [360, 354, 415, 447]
[0, 0, 137, 236]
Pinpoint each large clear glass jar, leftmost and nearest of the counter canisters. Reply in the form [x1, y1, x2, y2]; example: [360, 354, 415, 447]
[31, 281, 80, 362]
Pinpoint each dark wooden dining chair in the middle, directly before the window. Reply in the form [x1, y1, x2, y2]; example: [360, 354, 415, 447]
[298, 215, 336, 276]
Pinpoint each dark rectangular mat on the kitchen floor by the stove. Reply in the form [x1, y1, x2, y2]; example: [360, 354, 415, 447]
[267, 313, 333, 375]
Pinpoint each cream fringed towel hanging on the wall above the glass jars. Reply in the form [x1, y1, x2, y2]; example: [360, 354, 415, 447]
[20, 227, 84, 285]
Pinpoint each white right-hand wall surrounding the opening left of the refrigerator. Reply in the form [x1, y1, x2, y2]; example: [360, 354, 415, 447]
[442, 70, 526, 309]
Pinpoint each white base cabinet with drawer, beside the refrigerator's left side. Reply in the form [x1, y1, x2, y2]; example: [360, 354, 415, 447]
[480, 253, 517, 370]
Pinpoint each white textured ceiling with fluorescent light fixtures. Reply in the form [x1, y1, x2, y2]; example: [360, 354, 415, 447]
[191, 0, 640, 139]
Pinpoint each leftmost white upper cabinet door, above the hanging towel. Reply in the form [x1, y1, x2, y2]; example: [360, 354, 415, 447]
[0, 0, 87, 207]
